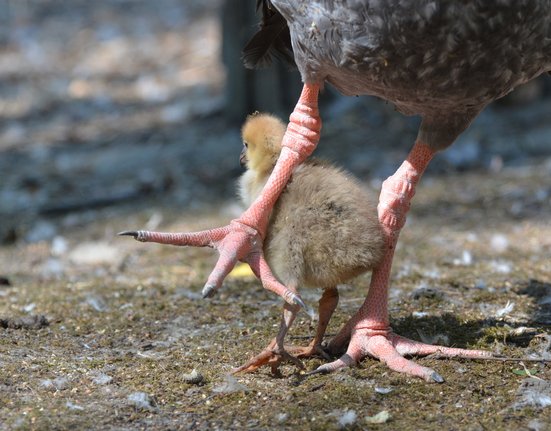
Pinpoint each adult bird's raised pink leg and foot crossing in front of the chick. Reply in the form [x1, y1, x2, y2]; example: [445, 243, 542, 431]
[120, 84, 321, 308]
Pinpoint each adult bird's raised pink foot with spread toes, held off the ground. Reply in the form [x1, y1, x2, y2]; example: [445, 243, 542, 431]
[119, 219, 312, 315]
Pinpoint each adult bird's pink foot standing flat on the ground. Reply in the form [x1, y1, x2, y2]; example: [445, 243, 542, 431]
[308, 328, 494, 383]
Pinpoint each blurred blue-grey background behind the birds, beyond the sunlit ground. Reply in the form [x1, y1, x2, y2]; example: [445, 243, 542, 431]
[0, 0, 551, 245]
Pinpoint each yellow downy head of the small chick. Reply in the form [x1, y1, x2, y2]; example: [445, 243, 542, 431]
[241, 113, 285, 175]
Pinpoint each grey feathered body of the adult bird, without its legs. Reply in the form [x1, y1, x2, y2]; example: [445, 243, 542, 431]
[271, 0, 551, 148]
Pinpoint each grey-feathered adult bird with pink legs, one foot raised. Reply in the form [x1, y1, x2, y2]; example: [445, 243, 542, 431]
[124, 0, 551, 382]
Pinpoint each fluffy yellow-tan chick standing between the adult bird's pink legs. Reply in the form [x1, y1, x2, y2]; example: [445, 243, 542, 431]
[234, 113, 385, 373]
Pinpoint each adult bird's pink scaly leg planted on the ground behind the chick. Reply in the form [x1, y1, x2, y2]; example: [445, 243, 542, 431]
[315, 141, 493, 383]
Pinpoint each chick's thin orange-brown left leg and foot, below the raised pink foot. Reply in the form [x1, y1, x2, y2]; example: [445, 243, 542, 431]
[232, 303, 304, 375]
